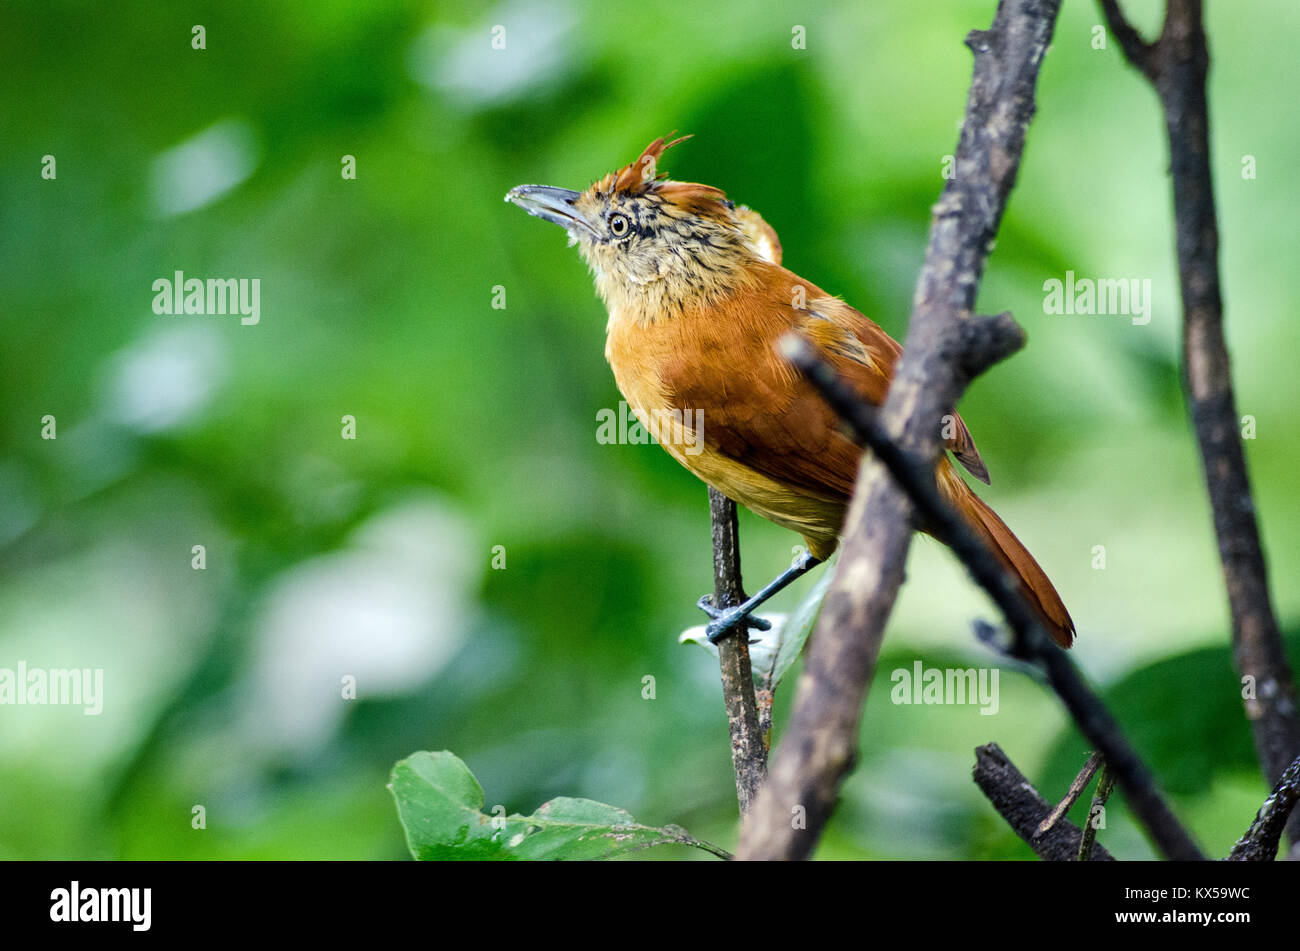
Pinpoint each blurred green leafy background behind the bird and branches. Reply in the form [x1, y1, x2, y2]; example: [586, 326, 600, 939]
[0, 0, 1300, 859]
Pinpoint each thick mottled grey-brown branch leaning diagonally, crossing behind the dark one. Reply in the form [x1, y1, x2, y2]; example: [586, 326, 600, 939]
[738, 0, 1060, 859]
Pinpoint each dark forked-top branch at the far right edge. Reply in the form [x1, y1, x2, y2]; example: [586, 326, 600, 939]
[1101, 0, 1300, 843]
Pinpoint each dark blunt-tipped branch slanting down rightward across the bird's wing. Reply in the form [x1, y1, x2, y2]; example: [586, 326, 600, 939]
[784, 336, 1204, 860]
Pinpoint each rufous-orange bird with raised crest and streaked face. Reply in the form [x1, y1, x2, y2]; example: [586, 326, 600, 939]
[506, 135, 1075, 648]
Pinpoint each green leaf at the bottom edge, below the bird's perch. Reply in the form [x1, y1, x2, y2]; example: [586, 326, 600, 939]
[389, 751, 729, 861]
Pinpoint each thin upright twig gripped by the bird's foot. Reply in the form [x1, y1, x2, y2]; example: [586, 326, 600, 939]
[709, 488, 767, 816]
